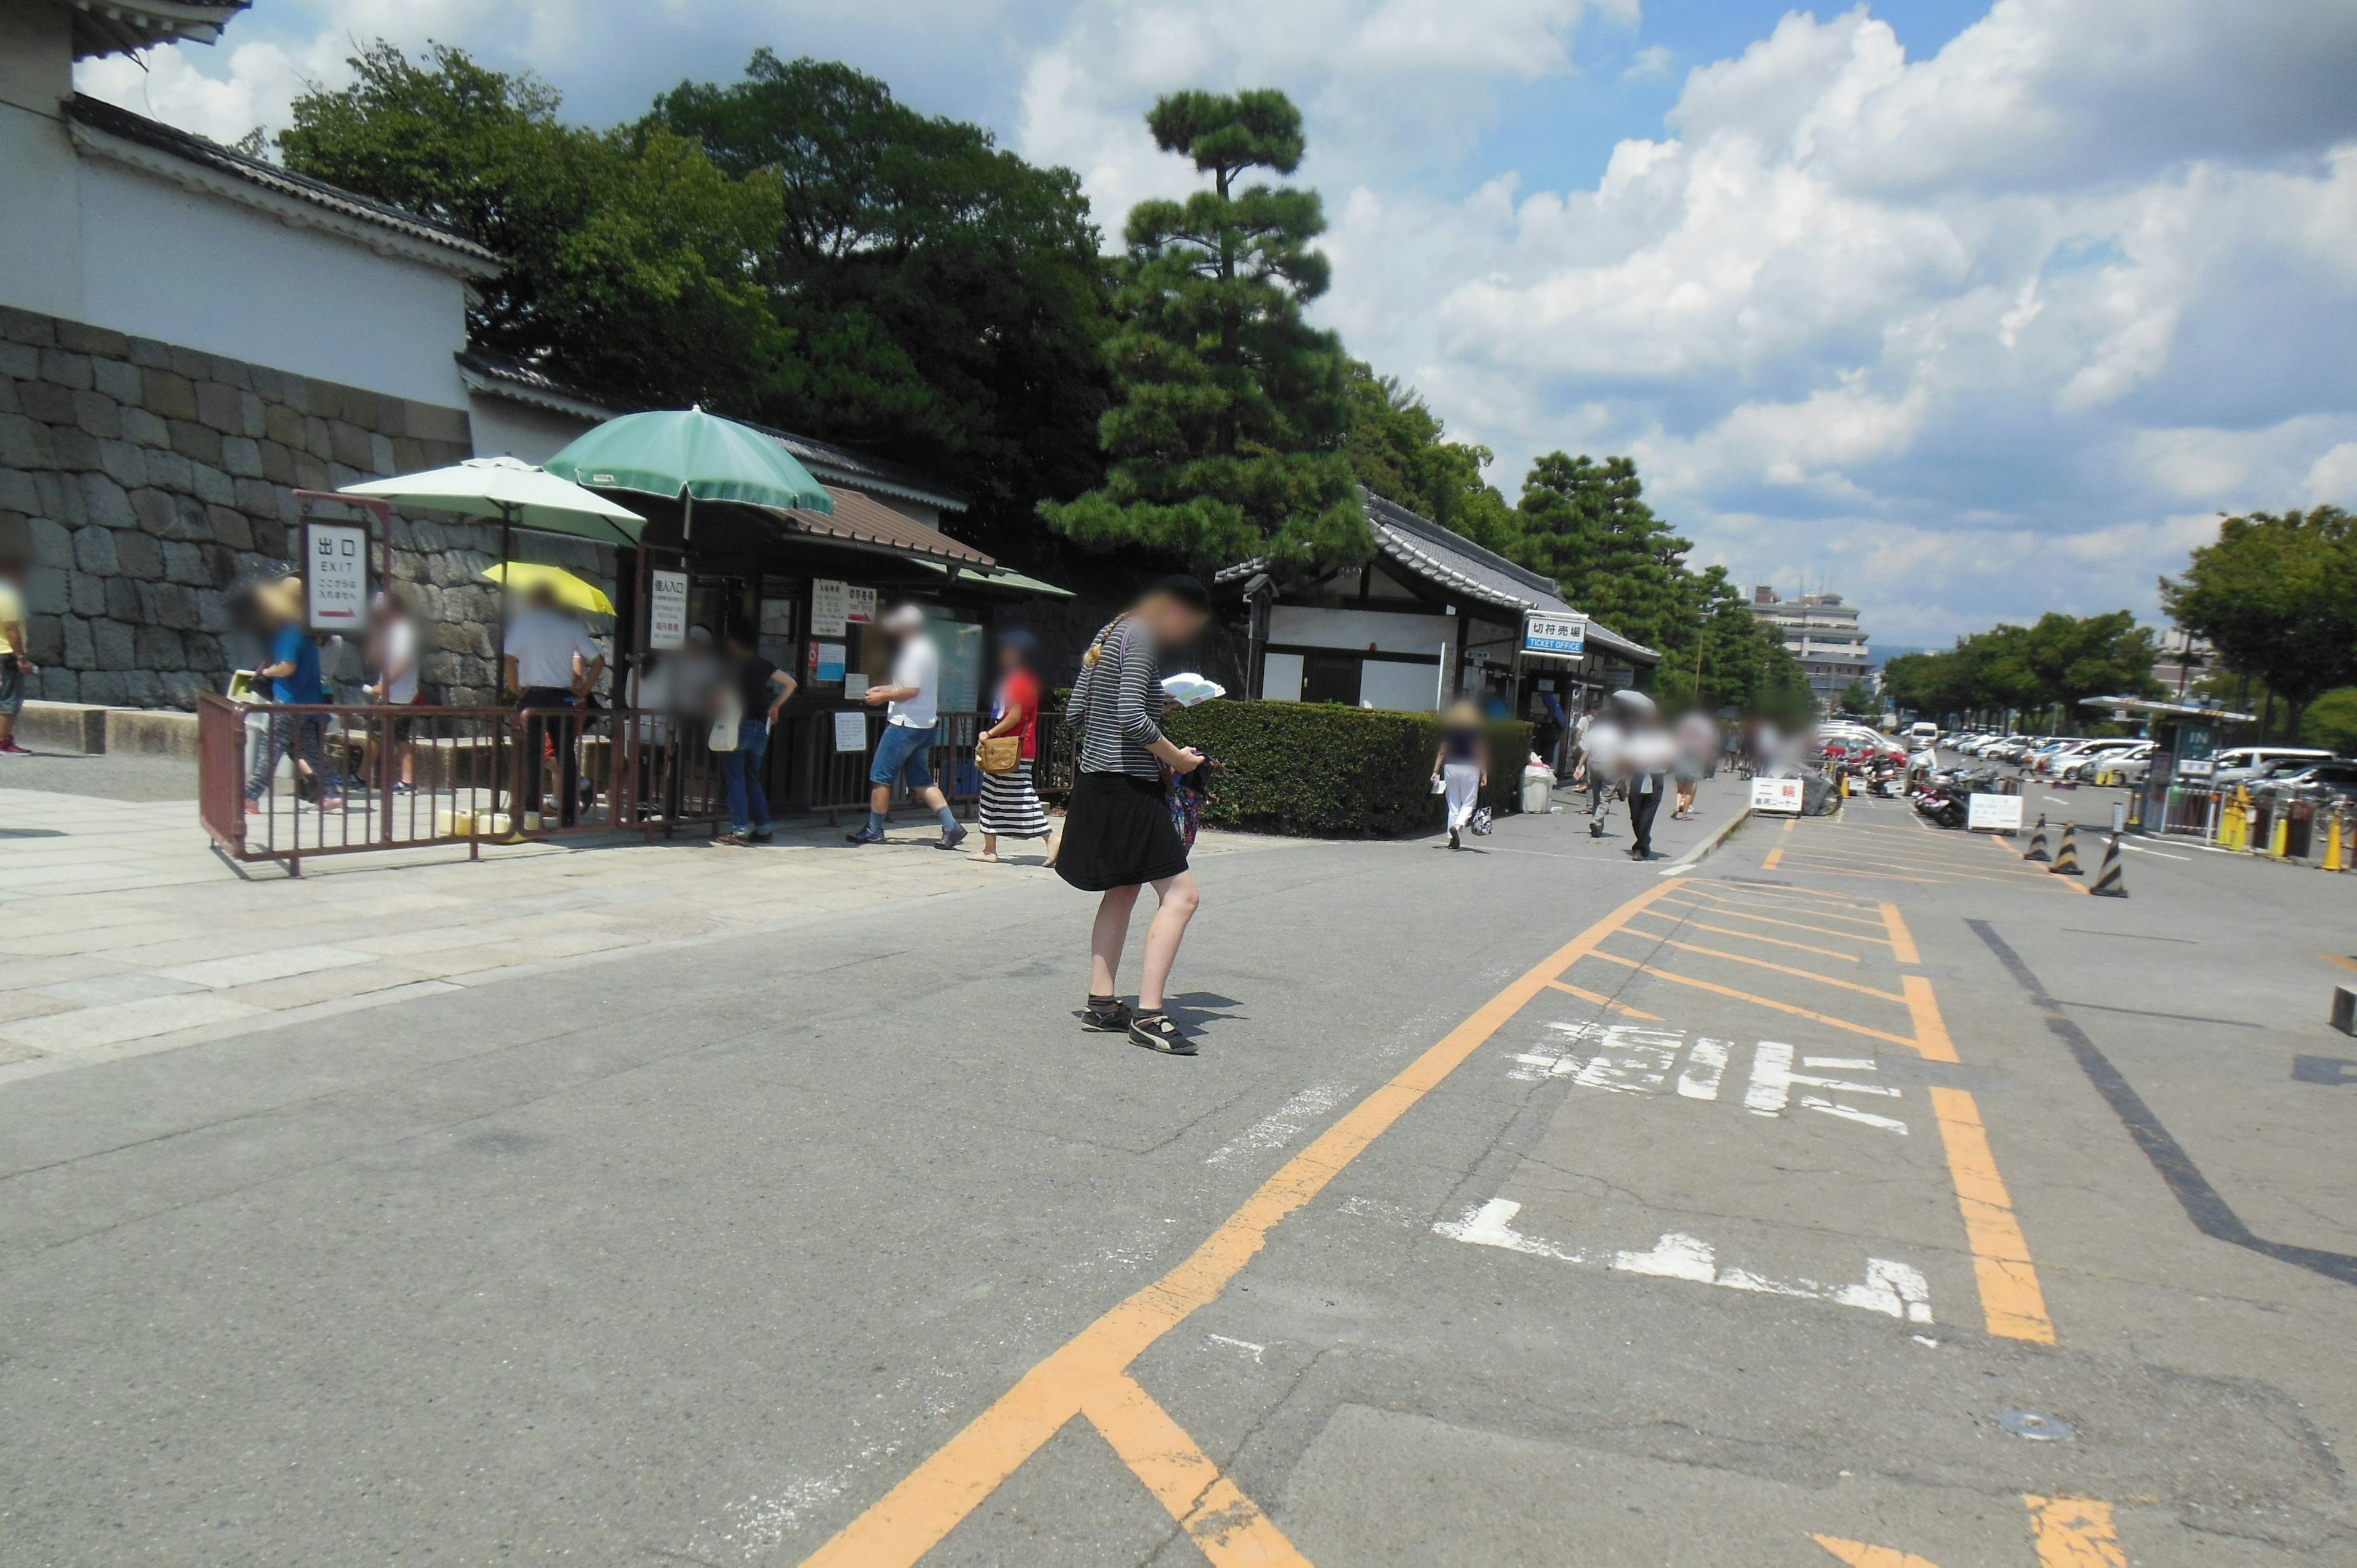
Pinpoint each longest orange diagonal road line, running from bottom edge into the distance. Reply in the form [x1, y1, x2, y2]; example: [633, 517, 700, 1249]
[803, 877, 1686, 1568]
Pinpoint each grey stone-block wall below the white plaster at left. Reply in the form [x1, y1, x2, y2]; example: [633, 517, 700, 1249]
[0, 309, 613, 708]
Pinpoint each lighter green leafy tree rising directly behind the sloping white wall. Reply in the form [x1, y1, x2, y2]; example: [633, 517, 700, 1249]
[278, 42, 788, 408]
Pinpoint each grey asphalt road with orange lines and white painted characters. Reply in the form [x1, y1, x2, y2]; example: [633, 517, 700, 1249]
[0, 797, 2357, 1568]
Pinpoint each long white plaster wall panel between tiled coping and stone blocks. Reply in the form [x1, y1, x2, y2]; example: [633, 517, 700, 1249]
[80, 158, 466, 408]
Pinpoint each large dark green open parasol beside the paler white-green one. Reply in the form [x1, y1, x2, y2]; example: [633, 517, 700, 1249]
[542, 408, 834, 538]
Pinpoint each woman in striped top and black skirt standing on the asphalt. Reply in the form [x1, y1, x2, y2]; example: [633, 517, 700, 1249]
[1056, 577, 1212, 1056]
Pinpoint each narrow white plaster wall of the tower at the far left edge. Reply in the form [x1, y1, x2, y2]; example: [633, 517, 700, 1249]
[0, 0, 82, 321]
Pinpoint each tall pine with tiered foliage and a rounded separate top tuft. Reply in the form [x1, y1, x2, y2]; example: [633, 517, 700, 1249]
[1039, 90, 1372, 568]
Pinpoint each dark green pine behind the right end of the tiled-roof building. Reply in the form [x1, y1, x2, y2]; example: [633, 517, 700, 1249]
[1518, 453, 1701, 667]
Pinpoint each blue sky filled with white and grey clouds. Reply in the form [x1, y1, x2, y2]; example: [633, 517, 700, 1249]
[80, 0, 2357, 646]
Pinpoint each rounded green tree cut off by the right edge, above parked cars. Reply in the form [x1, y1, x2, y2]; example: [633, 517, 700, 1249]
[2161, 507, 2357, 736]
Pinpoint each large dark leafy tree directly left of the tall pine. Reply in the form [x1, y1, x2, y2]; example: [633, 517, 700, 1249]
[637, 47, 1110, 549]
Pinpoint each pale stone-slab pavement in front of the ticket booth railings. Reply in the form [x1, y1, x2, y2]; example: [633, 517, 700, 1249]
[0, 790, 1291, 1084]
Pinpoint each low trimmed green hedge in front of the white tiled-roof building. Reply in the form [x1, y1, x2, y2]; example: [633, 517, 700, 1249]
[1162, 700, 1532, 840]
